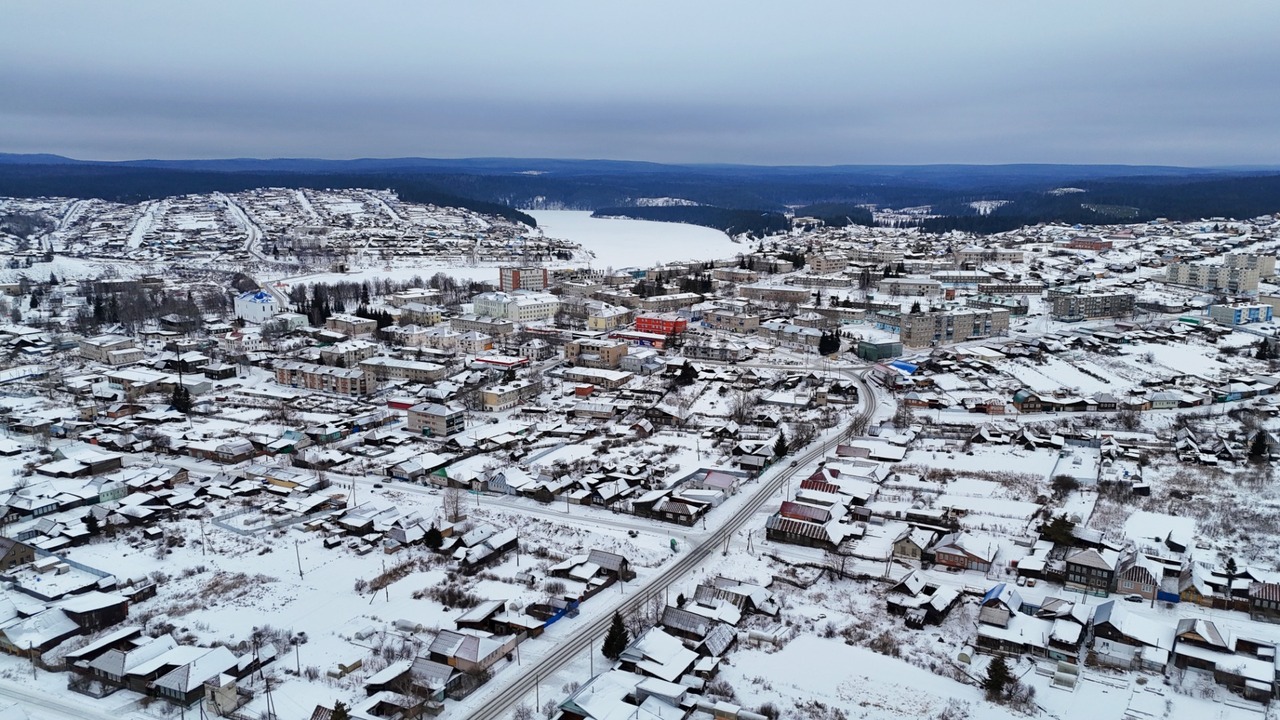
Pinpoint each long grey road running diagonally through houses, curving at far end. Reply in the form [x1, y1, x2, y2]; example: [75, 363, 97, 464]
[467, 373, 878, 720]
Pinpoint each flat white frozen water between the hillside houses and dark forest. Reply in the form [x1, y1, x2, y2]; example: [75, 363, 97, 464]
[525, 210, 750, 270]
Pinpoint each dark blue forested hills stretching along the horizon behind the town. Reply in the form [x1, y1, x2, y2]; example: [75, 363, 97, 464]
[0, 154, 1280, 233]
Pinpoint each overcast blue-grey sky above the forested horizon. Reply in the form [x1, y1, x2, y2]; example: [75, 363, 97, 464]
[0, 0, 1280, 165]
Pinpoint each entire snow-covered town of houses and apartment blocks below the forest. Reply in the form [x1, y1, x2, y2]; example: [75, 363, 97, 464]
[0, 188, 1280, 720]
